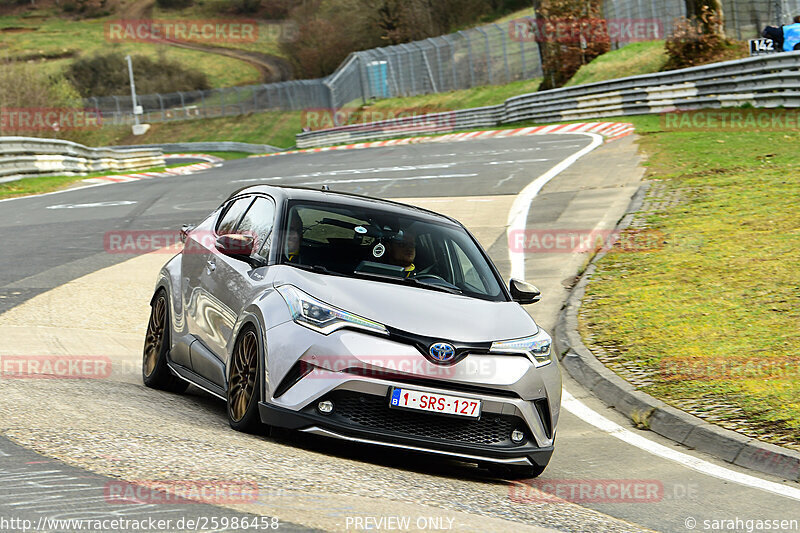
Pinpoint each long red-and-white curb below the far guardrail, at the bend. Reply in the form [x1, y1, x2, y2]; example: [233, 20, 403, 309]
[249, 122, 634, 157]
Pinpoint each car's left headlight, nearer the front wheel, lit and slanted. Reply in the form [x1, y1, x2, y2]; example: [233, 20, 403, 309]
[277, 285, 389, 335]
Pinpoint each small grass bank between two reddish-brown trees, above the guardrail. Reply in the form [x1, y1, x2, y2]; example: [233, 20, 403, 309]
[567, 41, 667, 87]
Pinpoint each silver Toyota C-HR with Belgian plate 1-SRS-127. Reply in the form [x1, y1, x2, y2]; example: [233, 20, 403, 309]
[142, 186, 561, 477]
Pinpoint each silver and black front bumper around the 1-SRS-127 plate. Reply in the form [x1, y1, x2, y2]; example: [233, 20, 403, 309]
[259, 323, 561, 466]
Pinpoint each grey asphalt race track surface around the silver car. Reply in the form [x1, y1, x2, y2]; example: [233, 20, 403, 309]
[0, 135, 800, 532]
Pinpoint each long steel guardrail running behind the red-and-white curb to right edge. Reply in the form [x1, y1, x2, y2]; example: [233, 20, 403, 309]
[297, 52, 800, 148]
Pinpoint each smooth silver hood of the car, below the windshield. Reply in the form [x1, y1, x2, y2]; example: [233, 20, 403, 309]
[273, 266, 538, 342]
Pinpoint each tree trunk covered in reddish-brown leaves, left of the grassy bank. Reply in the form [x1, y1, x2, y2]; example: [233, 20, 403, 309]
[531, 0, 611, 91]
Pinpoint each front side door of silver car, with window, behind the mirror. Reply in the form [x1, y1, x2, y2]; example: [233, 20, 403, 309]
[192, 196, 275, 386]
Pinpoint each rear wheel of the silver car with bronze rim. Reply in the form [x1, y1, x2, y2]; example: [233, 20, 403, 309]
[142, 289, 189, 393]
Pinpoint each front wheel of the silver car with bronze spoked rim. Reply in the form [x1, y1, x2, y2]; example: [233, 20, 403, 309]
[225, 325, 269, 434]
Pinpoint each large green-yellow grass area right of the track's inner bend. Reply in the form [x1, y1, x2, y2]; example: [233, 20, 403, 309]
[580, 112, 800, 447]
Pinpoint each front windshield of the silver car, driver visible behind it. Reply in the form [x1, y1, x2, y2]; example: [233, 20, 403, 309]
[279, 203, 506, 301]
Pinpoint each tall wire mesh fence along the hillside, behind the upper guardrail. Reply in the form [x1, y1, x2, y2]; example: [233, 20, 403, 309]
[84, 0, 800, 125]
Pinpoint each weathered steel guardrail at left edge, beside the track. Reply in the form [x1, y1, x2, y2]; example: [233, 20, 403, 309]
[0, 137, 164, 182]
